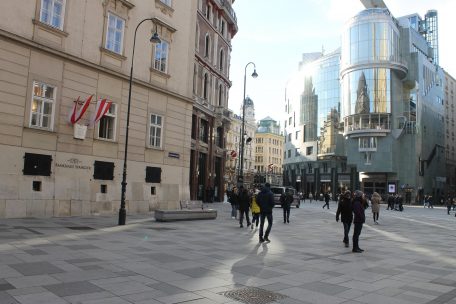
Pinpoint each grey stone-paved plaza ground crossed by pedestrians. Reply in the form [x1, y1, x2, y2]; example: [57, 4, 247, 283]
[0, 202, 456, 304]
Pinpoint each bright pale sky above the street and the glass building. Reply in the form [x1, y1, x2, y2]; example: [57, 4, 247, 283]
[228, 0, 456, 122]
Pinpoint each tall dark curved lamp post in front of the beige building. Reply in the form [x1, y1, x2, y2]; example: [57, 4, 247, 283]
[119, 18, 161, 225]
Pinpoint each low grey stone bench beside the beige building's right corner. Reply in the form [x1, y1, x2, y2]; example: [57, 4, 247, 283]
[155, 201, 217, 222]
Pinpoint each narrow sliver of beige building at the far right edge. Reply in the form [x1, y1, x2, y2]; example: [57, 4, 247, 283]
[444, 72, 456, 194]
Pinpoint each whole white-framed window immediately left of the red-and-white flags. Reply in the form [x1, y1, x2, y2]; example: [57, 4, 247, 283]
[30, 81, 56, 130]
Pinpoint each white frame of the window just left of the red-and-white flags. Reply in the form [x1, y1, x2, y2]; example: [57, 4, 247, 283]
[29, 81, 57, 131]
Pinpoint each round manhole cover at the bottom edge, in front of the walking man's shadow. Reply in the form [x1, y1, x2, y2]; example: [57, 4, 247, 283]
[219, 287, 286, 304]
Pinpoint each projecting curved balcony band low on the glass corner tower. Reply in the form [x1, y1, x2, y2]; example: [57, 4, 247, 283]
[344, 113, 391, 137]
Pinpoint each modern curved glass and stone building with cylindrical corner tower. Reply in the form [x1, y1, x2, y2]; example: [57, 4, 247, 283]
[284, 6, 446, 200]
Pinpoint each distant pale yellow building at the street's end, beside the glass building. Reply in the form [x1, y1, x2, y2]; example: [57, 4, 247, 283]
[254, 116, 284, 188]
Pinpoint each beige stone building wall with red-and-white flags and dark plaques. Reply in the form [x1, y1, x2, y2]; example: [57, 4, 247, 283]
[0, 0, 197, 218]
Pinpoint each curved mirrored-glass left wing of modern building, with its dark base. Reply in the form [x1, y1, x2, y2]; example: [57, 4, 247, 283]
[283, 50, 354, 195]
